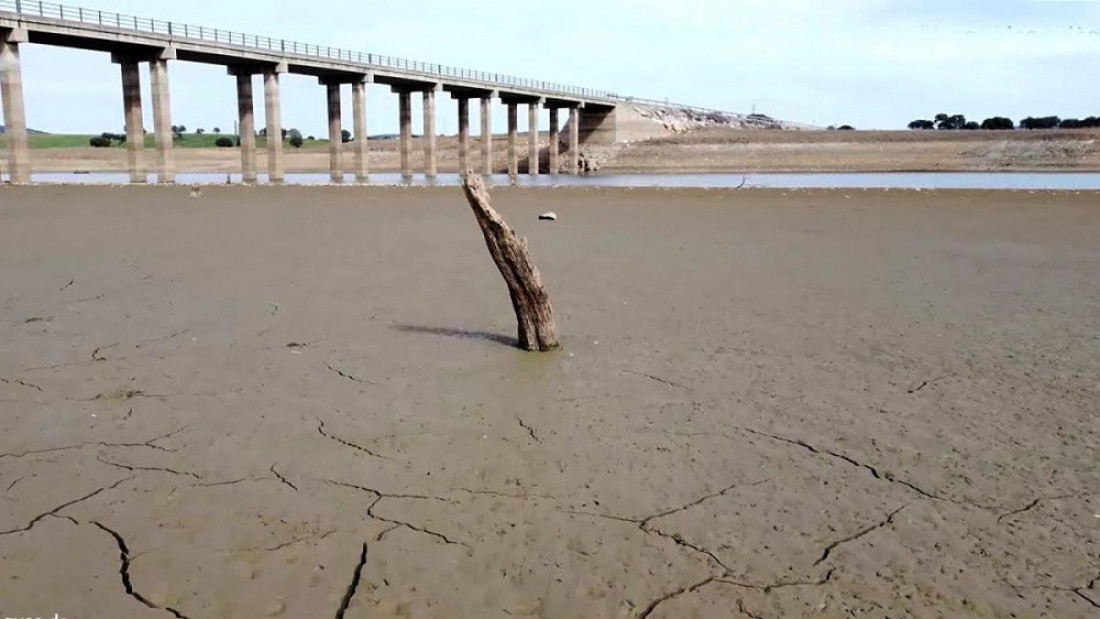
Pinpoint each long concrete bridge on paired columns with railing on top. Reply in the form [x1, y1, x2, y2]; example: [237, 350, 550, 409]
[0, 0, 726, 183]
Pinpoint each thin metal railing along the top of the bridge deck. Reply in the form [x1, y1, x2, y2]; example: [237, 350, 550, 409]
[0, 0, 818, 125]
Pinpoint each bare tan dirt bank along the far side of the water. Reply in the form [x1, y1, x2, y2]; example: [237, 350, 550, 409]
[8, 125, 1100, 174]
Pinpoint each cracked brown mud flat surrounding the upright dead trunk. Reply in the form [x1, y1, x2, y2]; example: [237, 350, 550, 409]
[0, 187, 1100, 619]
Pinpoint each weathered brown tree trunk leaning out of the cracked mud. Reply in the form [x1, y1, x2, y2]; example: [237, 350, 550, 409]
[462, 174, 561, 352]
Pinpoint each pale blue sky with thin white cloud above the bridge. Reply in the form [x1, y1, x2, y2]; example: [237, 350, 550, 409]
[0, 0, 1100, 136]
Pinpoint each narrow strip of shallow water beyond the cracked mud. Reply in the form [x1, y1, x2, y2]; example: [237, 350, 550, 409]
[10, 172, 1100, 190]
